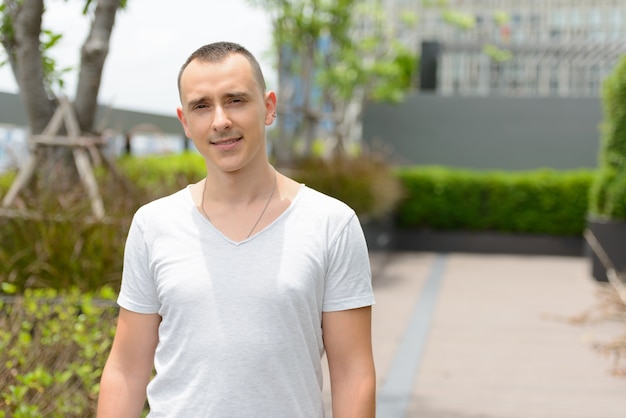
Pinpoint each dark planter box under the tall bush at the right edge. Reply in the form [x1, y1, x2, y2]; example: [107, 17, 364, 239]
[587, 219, 626, 282]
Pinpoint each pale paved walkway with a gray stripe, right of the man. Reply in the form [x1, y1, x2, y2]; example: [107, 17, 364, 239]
[325, 253, 626, 418]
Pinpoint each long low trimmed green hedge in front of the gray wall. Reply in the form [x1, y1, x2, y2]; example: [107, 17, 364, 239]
[397, 167, 594, 236]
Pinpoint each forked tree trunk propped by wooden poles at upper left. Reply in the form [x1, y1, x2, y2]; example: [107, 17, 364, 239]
[0, 0, 126, 193]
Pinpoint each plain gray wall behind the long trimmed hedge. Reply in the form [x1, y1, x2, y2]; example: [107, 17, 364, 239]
[363, 94, 602, 170]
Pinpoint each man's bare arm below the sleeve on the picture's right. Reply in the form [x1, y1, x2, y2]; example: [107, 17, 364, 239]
[322, 306, 376, 418]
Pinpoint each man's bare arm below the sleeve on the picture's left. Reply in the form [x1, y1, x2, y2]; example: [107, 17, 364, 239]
[97, 308, 161, 418]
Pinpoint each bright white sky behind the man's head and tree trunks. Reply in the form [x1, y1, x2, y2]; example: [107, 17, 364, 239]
[0, 0, 275, 116]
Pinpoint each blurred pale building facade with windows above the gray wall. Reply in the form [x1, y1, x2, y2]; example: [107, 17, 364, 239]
[387, 0, 626, 97]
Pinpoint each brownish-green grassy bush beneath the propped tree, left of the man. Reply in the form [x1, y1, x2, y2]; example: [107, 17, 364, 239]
[0, 173, 138, 291]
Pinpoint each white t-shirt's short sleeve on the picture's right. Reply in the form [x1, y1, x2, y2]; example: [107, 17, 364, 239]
[322, 213, 374, 312]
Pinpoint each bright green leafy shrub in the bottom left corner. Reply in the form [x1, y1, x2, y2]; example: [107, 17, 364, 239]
[0, 283, 117, 418]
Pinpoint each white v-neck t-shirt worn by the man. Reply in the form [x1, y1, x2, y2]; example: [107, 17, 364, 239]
[118, 186, 374, 418]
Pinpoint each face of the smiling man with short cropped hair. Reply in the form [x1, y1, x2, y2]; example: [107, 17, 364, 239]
[178, 54, 276, 172]
